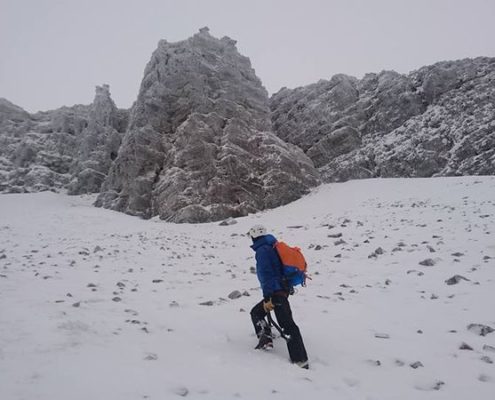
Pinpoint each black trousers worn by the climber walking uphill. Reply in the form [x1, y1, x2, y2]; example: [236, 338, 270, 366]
[251, 295, 308, 362]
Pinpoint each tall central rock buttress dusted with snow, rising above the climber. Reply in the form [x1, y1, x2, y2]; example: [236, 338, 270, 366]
[96, 28, 318, 222]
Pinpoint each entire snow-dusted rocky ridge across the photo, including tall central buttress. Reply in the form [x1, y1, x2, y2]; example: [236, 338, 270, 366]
[0, 28, 495, 222]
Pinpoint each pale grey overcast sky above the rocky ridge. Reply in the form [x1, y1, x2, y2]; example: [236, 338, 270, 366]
[0, 0, 495, 112]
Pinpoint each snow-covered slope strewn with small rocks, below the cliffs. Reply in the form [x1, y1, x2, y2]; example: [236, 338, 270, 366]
[0, 177, 495, 400]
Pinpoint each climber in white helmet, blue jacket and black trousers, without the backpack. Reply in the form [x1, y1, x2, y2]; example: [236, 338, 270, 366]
[248, 225, 309, 369]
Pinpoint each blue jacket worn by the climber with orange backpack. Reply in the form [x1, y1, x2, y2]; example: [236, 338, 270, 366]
[251, 235, 284, 298]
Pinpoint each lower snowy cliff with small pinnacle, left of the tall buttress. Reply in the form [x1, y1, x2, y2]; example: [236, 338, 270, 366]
[0, 85, 127, 194]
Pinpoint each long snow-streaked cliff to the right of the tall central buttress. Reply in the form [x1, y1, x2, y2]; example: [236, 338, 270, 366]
[271, 58, 495, 181]
